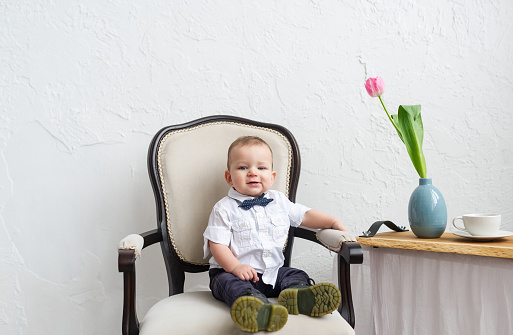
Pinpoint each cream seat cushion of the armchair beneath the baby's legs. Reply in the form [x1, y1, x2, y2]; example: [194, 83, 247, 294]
[140, 291, 354, 335]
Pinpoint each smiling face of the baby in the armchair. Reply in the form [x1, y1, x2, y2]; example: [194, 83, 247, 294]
[225, 144, 276, 197]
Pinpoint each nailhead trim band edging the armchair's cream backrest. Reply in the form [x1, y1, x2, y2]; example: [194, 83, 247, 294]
[157, 122, 292, 265]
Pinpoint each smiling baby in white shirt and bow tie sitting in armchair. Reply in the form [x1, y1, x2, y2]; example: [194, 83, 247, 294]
[203, 136, 346, 332]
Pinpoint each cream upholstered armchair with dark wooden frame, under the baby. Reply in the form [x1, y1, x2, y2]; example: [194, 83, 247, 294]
[118, 115, 363, 335]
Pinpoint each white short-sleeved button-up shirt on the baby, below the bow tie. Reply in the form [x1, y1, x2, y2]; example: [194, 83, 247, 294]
[203, 187, 310, 286]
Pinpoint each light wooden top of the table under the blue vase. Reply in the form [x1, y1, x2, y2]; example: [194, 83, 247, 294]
[356, 231, 513, 259]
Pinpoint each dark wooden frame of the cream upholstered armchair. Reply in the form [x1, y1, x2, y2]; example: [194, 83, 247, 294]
[118, 115, 363, 335]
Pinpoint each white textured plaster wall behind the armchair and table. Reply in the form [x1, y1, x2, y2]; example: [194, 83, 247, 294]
[0, 0, 513, 335]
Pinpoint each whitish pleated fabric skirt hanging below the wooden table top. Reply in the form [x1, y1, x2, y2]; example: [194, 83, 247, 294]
[365, 247, 513, 335]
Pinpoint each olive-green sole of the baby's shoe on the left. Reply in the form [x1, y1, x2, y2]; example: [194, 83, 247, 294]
[231, 296, 288, 332]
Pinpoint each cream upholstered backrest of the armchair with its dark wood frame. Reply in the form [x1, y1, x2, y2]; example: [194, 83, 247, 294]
[149, 116, 300, 271]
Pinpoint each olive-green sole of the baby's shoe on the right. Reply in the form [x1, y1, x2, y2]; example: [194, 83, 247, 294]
[278, 283, 342, 316]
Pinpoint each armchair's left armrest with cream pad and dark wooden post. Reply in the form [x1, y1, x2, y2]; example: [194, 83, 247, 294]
[118, 229, 162, 335]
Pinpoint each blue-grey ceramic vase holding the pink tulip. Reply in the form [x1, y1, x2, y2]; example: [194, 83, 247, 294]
[408, 178, 447, 238]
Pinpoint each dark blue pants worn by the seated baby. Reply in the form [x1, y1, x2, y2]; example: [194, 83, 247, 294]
[209, 267, 310, 306]
